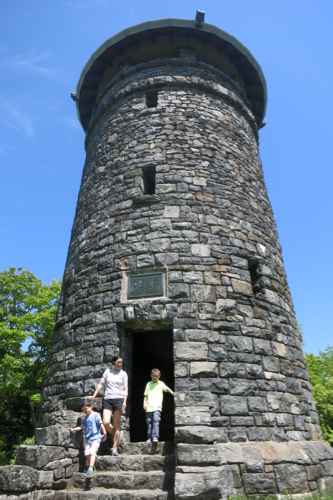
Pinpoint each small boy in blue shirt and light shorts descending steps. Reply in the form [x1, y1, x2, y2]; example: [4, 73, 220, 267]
[69, 399, 106, 477]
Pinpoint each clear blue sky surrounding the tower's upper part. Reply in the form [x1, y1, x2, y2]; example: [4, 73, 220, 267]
[0, 0, 333, 353]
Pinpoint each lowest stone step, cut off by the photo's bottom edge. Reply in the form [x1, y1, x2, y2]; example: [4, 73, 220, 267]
[64, 488, 174, 500]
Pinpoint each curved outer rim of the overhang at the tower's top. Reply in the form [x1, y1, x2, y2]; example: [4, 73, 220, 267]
[76, 18, 267, 132]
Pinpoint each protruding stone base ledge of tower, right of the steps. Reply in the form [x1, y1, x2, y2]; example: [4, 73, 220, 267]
[175, 442, 333, 500]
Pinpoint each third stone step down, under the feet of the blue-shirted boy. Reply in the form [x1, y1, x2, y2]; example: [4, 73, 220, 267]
[73, 471, 175, 491]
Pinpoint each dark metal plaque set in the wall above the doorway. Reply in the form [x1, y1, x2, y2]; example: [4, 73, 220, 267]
[127, 272, 164, 299]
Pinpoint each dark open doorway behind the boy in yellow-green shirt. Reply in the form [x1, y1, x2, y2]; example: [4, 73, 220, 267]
[130, 330, 175, 442]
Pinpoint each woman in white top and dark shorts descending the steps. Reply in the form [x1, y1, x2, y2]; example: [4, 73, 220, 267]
[93, 356, 128, 457]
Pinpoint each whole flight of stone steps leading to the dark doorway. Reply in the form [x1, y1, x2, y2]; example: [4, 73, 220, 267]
[68, 442, 175, 500]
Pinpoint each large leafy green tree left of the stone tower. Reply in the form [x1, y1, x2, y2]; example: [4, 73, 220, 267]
[0, 267, 61, 464]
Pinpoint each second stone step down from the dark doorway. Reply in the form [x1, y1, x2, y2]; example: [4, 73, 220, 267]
[96, 454, 175, 472]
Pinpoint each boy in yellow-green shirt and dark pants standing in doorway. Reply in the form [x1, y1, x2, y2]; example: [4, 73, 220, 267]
[143, 368, 174, 443]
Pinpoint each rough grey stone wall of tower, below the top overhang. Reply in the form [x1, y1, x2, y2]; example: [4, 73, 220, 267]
[1, 49, 333, 499]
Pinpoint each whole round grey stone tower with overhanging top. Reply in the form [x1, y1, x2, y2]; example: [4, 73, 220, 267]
[0, 19, 333, 500]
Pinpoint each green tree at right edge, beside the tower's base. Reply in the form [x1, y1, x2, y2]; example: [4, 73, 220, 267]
[306, 346, 333, 446]
